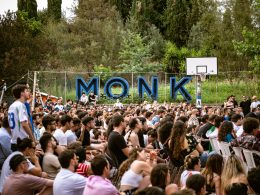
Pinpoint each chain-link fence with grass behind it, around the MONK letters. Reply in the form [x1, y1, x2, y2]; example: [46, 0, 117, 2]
[28, 71, 260, 104]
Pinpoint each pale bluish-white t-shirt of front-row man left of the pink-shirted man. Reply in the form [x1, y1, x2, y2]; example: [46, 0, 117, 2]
[53, 168, 86, 195]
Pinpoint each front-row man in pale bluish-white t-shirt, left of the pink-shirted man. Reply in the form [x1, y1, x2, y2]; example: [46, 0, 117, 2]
[53, 150, 86, 195]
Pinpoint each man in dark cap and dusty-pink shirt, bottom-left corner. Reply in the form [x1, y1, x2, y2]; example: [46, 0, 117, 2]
[2, 154, 53, 195]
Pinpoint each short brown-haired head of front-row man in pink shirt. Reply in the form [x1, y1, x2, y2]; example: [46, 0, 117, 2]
[91, 155, 110, 178]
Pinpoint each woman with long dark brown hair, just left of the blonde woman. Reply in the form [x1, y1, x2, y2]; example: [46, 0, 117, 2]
[201, 153, 224, 195]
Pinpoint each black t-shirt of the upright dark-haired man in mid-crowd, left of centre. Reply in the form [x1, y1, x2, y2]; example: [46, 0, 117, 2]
[108, 131, 127, 165]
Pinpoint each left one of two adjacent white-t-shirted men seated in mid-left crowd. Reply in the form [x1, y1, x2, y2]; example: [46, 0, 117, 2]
[53, 115, 72, 146]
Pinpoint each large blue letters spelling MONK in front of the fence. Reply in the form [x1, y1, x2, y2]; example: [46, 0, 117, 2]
[76, 77, 192, 101]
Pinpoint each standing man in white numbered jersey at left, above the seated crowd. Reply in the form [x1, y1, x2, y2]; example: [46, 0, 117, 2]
[8, 84, 35, 151]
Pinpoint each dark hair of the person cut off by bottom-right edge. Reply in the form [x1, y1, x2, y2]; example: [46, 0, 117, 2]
[247, 166, 260, 194]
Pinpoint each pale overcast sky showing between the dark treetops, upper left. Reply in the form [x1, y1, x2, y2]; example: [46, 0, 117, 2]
[0, 0, 74, 18]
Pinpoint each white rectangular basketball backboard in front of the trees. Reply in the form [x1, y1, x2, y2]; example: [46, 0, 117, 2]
[186, 57, 218, 75]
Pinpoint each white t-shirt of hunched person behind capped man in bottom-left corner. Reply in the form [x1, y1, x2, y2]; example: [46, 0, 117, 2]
[0, 151, 35, 193]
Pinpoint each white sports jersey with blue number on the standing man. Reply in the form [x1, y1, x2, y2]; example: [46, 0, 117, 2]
[8, 100, 29, 144]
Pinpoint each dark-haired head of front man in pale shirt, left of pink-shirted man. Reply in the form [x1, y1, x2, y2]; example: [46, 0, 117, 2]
[59, 150, 78, 171]
